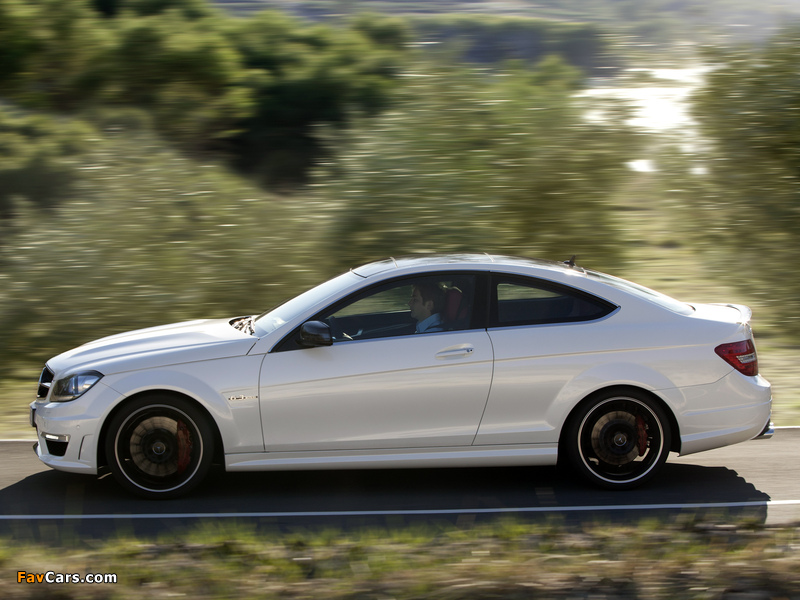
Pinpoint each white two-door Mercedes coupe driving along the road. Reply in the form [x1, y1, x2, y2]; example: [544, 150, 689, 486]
[31, 255, 772, 498]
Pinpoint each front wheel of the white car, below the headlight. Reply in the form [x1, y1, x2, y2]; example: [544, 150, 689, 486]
[105, 395, 214, 499]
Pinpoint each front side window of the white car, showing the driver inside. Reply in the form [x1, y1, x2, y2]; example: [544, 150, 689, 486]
[318, 273, 475, 343]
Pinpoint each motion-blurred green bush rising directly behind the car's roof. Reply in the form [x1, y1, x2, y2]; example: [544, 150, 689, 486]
[313, 57, 635, 266]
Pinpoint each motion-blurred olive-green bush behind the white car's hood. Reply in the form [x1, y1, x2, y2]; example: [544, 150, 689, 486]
[0, 124, 322, 370]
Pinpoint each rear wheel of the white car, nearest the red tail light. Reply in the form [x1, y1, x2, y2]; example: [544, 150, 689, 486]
[564, 391, 672, 490]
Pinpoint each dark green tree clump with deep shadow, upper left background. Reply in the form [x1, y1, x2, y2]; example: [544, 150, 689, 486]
[0, 0, 408, 183]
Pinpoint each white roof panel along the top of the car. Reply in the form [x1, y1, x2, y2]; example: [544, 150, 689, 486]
[351, 253, 583, 278]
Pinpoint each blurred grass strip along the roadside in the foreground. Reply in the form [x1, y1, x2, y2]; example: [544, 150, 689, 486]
[0, 515, 800, 600]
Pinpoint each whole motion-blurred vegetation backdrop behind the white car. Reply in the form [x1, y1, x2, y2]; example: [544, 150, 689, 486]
[0, 0, 800, 428]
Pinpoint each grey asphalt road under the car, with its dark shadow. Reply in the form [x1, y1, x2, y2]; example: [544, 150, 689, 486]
[0, 428, 800, 541]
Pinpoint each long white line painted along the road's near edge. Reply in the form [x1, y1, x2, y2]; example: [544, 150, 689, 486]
[0, 500, 800, 521]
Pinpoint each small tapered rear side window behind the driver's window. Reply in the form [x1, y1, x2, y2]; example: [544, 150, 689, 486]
[491, 276, 616, 327]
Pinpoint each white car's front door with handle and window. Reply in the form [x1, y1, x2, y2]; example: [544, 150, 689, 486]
[260, 273, 493, 451]
